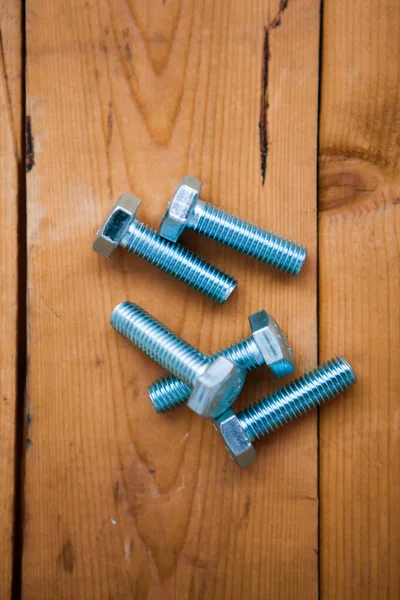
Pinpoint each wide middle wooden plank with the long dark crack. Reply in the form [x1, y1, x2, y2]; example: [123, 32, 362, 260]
[23, 0, 319, 599]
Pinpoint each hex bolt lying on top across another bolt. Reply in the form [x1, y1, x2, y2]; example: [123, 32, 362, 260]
[110, 302, 245, 419]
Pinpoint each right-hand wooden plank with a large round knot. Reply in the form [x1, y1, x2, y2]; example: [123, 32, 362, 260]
[319, 0, 400, 600]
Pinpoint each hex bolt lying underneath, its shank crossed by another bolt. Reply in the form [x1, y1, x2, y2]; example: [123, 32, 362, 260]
[149, 310, 294, 413]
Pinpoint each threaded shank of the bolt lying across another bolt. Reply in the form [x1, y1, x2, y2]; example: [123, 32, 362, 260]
[110, 302, 209, 386]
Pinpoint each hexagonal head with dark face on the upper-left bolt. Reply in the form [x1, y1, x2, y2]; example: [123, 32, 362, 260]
[93, 193, 141, 258]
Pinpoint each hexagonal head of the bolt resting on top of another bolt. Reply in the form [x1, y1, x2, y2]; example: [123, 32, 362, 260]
[187, 356, 246, 419]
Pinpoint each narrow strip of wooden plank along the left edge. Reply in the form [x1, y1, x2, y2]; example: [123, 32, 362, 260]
[0, 1, 21, 598]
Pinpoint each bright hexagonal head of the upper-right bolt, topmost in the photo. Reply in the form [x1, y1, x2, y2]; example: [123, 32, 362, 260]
[160, 175, 202, 242]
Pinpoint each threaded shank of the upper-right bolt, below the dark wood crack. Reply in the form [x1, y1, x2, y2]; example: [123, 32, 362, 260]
[186, 200, 307, 275]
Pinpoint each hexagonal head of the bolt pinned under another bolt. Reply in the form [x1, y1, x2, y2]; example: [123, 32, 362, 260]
[249, 310, 294, 377]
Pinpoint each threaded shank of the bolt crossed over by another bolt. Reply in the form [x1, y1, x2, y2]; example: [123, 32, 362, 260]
[149, 337, 264, 413]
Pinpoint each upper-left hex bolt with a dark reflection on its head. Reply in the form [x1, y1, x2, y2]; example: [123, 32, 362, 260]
[93, 194, 237, 304]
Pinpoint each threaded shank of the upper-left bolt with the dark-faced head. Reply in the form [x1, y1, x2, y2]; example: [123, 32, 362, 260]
[120, 220, 237, 304]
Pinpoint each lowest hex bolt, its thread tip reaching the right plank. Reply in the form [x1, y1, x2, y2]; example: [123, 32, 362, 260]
[214, 357, 356, 467]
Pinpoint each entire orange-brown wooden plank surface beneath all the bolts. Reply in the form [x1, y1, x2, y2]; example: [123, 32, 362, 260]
[0, 0, 400, 600]
